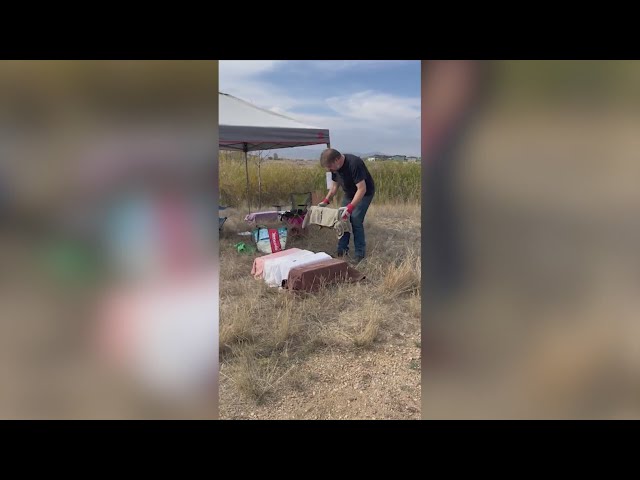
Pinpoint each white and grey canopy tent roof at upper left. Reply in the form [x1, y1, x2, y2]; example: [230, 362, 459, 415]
[218, 92, 330, 152]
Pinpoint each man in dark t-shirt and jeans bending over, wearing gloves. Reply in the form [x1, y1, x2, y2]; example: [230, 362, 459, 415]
[319, 148, 375, 263]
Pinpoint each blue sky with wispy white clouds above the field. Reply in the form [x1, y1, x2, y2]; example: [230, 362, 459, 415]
[219, 60, 421, 156]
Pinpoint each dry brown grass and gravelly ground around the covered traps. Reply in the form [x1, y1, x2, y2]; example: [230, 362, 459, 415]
[220, 200, 420, 419]
